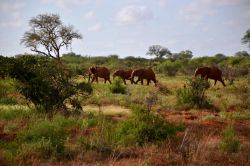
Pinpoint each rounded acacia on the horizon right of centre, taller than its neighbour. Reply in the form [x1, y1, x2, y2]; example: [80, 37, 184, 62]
[146, 45, 172, 59]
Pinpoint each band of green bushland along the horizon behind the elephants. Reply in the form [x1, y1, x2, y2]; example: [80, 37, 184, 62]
[0, 53, 250, 77]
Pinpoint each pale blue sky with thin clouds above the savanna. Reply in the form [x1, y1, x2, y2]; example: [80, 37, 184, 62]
[0, 0, 250, 58]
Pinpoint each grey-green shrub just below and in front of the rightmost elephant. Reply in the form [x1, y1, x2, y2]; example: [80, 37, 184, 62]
[176, 78, 211, 108]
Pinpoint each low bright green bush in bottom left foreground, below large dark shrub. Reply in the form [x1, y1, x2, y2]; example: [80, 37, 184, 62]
[17, 116, 77, 158]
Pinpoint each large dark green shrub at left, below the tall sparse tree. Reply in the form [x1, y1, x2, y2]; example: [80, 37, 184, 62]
[11, 55, 92, 112]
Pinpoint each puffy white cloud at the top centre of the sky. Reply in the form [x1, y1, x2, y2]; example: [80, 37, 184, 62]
[114, 5, 153, 24]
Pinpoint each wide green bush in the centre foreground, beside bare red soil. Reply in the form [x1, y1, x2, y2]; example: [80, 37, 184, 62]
[116, 106, 176, 146]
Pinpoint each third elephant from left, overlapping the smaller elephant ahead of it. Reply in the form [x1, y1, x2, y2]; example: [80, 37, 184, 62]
[130, 68, 157, 86]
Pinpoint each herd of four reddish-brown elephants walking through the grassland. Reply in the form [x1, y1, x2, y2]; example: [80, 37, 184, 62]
[87, 66, 226, 86]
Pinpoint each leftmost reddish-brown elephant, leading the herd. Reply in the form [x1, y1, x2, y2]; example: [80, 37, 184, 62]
[88, 66, 111, 84]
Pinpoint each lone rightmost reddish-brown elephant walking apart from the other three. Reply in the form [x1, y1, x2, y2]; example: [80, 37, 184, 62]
[194, 67, 226, 86]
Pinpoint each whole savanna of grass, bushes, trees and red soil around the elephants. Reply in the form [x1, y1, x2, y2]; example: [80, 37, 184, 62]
[0, 15, 250, 165]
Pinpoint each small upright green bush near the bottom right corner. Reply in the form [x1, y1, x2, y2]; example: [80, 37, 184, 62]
[219, 126, 240, 153]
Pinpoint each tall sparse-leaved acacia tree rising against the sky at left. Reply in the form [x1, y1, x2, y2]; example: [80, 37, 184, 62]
[21, 14, 82, 60]
